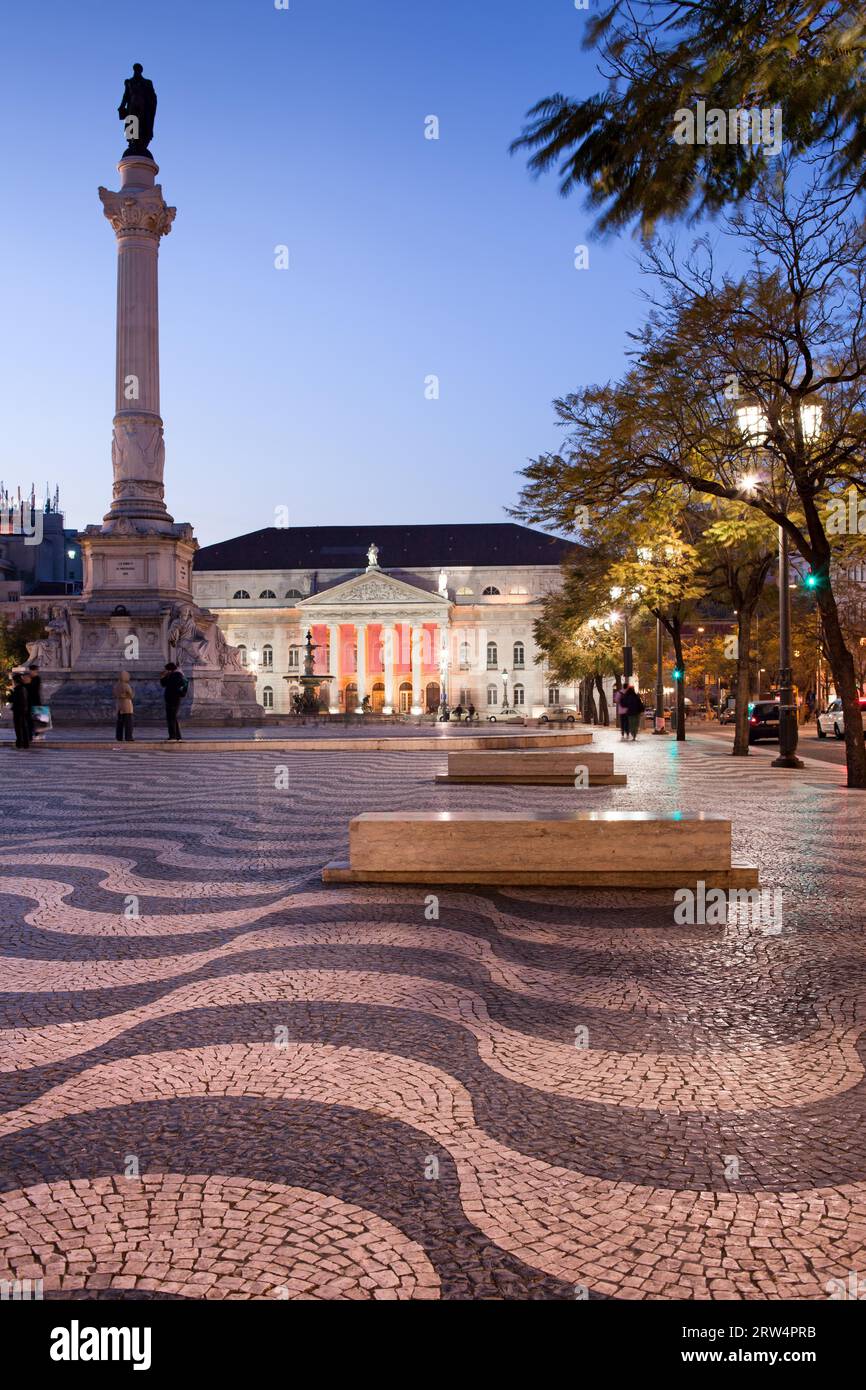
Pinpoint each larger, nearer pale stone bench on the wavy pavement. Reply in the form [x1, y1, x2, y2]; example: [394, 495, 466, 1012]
[322, 810, 758, 888]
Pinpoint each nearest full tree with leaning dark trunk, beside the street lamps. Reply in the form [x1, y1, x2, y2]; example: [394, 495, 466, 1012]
[520, 159, 866, 788]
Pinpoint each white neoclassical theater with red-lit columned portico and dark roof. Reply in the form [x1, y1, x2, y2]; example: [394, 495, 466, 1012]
[193, 521, 574, 717]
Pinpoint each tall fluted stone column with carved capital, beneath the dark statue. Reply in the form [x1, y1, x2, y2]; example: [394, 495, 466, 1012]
[99, 156, 177, 531]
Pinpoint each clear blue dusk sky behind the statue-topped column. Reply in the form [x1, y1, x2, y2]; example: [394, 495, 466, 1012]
[0, 0, 656, 544]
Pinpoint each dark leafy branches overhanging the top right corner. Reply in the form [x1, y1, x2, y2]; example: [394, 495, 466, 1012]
[512, 0, 866, 234]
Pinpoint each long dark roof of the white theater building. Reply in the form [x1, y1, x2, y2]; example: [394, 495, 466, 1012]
[195, 521, 571, 571]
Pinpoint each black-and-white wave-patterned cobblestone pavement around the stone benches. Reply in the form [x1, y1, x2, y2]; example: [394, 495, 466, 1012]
[0, 734, 866, 1300]
